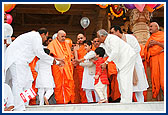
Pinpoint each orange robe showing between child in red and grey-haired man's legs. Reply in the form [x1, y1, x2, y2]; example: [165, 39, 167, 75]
[108, 61, 121, 101]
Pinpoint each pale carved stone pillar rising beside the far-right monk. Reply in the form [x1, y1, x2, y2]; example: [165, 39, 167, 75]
[130, 9, 150, 44]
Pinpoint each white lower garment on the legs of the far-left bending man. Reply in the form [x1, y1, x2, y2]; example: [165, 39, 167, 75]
[9, 63, 32, 111]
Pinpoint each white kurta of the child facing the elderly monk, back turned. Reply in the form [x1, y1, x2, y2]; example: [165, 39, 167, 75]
[36, 60, 55, 88]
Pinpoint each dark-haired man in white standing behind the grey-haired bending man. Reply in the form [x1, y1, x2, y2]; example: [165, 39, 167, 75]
[110, 26, 149, 102]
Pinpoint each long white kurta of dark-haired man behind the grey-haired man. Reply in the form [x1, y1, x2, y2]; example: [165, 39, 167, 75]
[125, 34, 149, 92]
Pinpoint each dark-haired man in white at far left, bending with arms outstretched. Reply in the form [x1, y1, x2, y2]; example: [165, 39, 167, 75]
[4, 28, 64, 111]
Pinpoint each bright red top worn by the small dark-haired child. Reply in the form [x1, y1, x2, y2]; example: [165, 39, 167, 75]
[94, 57, 109, 85]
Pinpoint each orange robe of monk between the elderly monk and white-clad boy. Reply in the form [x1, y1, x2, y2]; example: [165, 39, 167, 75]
[74, 45, 87, 103]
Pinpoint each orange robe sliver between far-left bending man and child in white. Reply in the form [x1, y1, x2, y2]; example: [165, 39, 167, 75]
[29, 56, 39, 105]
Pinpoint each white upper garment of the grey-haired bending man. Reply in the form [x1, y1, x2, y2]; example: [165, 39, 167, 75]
[104, 34, 135, 70]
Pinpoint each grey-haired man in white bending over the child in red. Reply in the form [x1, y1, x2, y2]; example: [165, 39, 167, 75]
[97, 29, 136, 103]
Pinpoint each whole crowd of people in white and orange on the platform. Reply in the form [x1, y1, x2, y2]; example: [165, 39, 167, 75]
[4, 22, 164, 111]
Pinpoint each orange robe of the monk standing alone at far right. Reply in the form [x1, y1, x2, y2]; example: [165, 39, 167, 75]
[144, 31, 164, 98]
